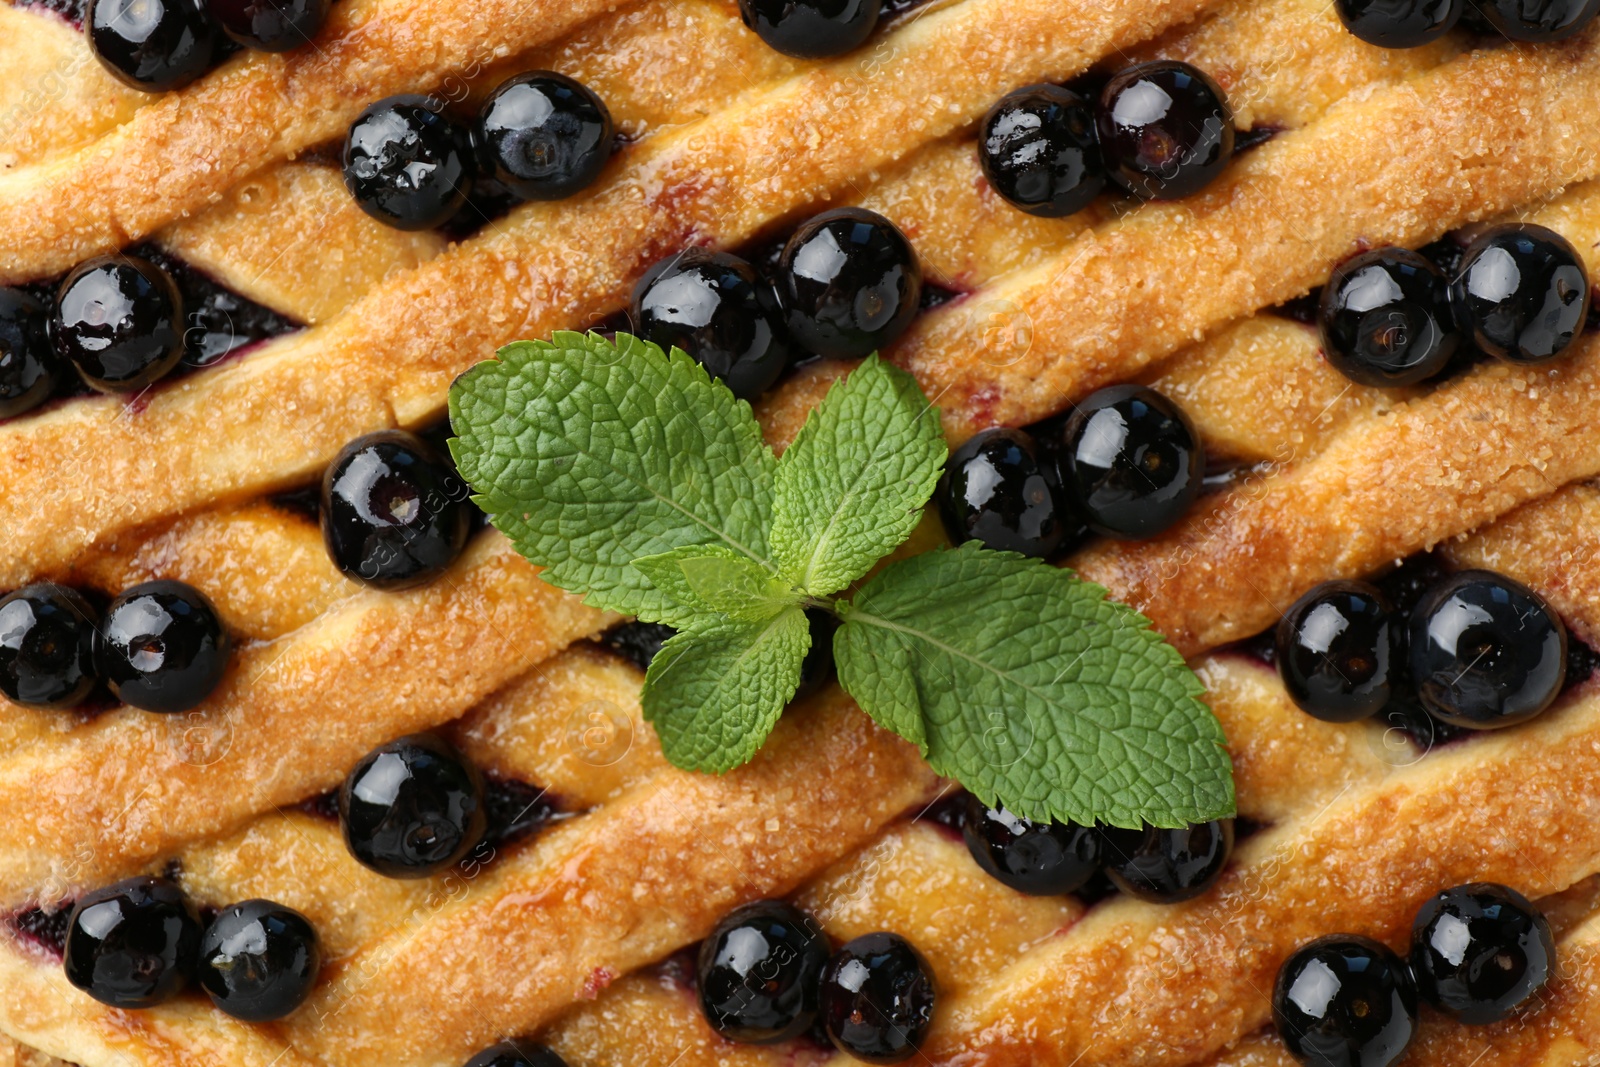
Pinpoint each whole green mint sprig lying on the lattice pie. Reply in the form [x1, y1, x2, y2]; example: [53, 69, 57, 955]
[450, 333, 1234, 827]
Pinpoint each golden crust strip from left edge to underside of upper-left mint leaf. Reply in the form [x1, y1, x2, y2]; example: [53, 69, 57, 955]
[0, 534, 605, 905]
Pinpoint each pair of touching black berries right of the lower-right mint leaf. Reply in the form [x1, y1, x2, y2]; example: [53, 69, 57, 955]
[1275, 571, 1568, 729]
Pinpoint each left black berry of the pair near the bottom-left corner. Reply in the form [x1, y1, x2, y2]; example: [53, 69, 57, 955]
[62, 877, 200, 1008]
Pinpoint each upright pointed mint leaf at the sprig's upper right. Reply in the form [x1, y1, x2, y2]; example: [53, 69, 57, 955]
[770, 355, 946, 597]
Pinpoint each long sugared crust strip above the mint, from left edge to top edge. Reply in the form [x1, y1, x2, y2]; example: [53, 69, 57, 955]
[0, 0, 1198, 584]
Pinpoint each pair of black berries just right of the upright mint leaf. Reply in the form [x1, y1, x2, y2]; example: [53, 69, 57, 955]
[934, 386, 1205, 558]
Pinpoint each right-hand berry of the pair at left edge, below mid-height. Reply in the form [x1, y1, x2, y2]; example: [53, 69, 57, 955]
[94, 581, 234, 712]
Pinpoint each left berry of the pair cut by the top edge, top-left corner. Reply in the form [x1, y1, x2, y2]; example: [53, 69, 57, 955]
[83, 0, 219, 93]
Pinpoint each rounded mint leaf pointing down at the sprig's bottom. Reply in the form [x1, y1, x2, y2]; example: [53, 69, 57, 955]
[643, 606, 811, 774]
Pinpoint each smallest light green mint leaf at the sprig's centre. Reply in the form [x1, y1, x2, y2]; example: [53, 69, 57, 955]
[634, 544, 802, 629]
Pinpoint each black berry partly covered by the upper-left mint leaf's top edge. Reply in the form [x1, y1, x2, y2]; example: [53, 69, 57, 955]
[634, 248, 789, 400]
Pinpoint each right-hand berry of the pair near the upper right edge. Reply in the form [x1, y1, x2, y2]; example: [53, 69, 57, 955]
[1450, 222, 1589, 363]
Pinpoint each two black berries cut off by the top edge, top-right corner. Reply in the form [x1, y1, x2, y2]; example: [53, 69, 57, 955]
[1334, 0, 1600, 48]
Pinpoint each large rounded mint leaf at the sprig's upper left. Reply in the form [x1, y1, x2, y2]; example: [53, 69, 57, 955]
[450, 333, 778, 619]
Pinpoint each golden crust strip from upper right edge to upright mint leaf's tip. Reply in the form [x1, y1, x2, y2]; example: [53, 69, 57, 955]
[894, 32, 1600, 440]
